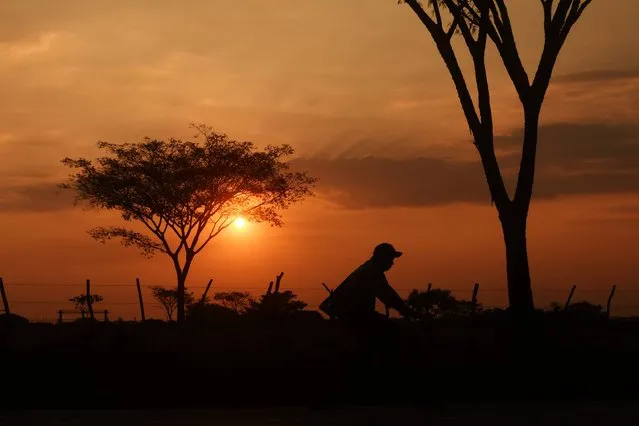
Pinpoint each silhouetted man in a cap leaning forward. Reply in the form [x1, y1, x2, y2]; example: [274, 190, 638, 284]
[320, 243, 414, 326]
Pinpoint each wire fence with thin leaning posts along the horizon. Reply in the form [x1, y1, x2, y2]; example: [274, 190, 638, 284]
[0, 280, 639, 322]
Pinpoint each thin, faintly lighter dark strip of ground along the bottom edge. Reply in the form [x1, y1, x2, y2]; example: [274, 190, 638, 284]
[0, 400, 639, 426]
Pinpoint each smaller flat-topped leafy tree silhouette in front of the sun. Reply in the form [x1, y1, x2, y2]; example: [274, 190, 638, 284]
[61, 125, 315, 321]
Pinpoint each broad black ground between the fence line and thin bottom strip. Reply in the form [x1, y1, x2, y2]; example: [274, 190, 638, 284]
[0, 319, 639, 412]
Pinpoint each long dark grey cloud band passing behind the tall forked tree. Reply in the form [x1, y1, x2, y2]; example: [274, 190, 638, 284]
[295, 123, 639, 209]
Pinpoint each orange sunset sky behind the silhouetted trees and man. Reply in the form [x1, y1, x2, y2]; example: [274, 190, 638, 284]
[0, 0, 639, 319]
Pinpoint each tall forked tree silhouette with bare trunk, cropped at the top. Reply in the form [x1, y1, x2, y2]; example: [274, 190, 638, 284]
[399, 0, 592, 318]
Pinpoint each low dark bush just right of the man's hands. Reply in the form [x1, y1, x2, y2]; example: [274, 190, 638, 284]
[406, 288, 481, 318]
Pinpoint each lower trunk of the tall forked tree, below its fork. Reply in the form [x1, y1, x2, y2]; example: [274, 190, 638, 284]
[501, 209, 535, 320]
